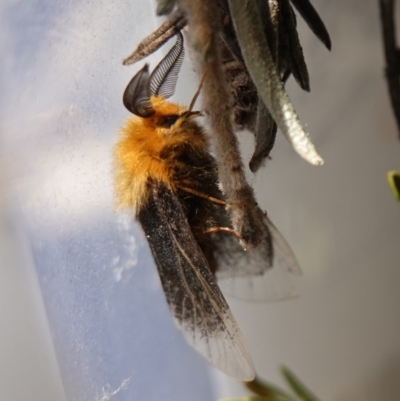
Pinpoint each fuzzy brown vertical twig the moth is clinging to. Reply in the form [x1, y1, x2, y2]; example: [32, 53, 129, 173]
[178, 0, 267, 248]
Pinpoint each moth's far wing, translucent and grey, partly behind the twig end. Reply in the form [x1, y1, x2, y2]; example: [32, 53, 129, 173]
[215, 212, 301, 301]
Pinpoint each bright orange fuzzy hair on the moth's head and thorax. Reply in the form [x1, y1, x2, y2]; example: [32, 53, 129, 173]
[115, 96, 202, 209]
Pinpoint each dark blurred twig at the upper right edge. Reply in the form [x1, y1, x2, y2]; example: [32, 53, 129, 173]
[379, 0, 400, 136]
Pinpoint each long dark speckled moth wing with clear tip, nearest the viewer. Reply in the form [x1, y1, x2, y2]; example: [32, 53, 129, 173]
[138, 184, 255, 380]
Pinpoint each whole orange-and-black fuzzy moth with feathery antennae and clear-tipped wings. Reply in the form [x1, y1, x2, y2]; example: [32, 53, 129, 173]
[114, 32, 300, 381]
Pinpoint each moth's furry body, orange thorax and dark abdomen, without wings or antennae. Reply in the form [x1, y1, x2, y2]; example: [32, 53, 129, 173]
[114, 96, 237, 272]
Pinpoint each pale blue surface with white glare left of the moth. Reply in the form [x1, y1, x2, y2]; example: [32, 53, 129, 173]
[1, 0, 213, 401]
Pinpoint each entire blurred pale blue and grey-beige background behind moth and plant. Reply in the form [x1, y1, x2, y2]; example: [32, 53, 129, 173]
[0, 0, 400, 401]
